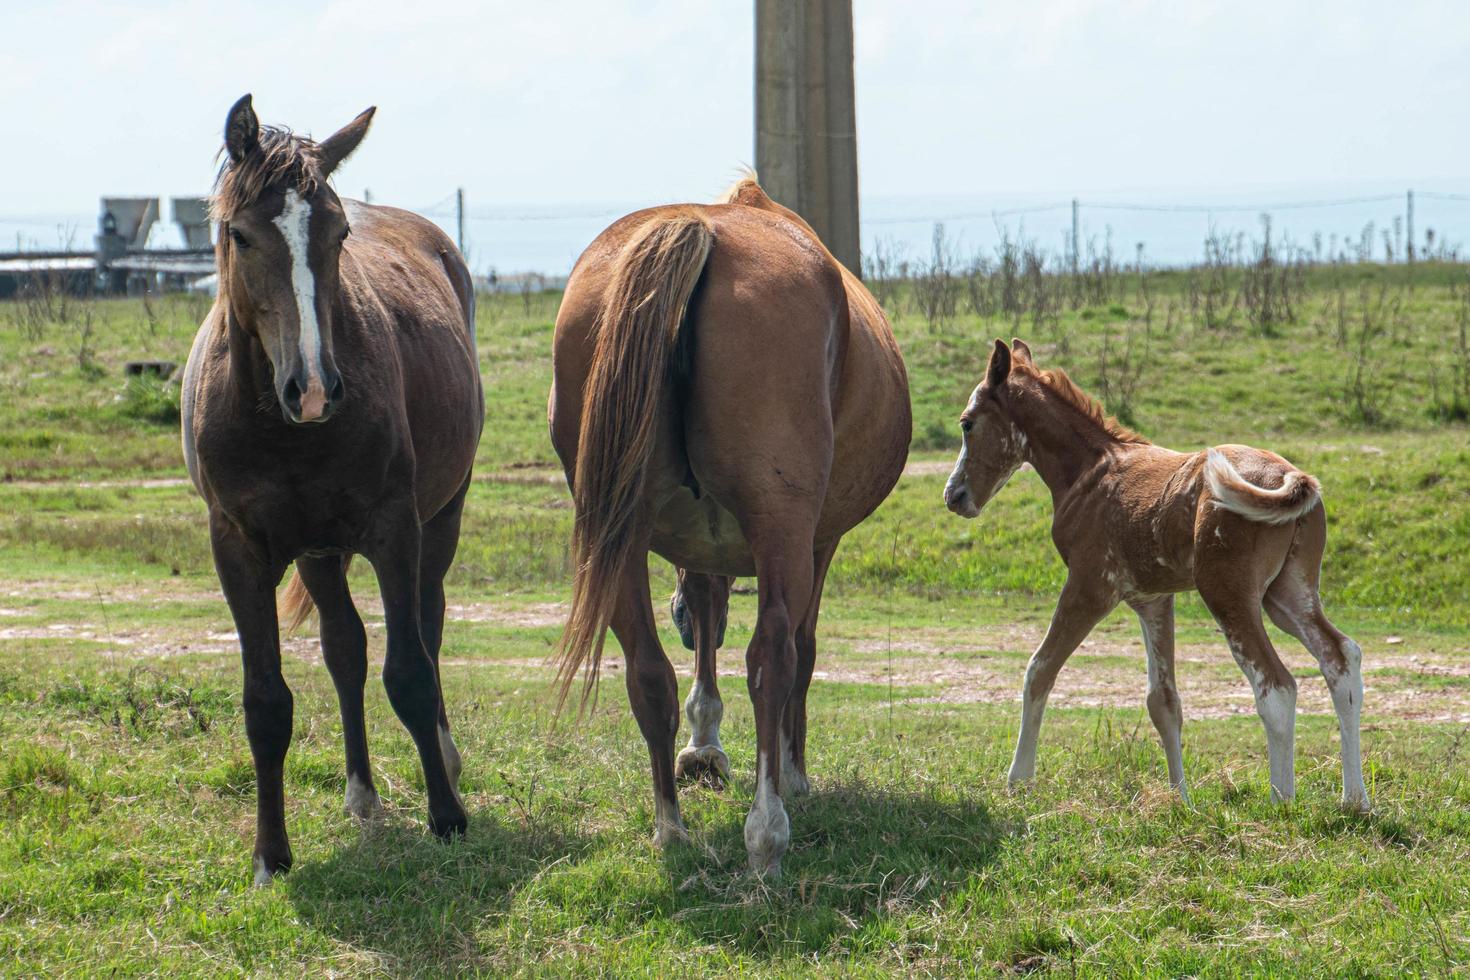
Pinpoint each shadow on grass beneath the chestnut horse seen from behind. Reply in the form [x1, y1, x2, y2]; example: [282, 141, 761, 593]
[664, 782, 1019, 956]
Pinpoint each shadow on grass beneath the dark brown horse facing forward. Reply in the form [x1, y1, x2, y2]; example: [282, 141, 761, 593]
[284, 810, 592, 973]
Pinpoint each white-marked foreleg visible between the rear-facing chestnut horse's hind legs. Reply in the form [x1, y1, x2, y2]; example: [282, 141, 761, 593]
[673, 572, 731, 785]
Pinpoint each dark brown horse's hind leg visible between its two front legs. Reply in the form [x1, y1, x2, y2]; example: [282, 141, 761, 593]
[295, 555, 382, 820]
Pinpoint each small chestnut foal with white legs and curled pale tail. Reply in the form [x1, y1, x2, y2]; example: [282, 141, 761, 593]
[944, 341, 1369, 810]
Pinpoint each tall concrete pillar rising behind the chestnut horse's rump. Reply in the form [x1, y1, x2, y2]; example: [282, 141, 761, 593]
[756, 0, 861, 273]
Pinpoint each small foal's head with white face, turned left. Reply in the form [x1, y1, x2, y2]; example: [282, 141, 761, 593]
[944, 341, 1030, 517]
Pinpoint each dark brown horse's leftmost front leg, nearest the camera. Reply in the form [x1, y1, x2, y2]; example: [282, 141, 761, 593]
[209, 513, 293, 884]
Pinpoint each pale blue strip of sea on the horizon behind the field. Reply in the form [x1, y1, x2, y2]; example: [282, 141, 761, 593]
[0, 178, 1470, 278]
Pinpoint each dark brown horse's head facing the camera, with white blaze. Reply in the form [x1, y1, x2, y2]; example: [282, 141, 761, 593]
[213, 96, 373, 423]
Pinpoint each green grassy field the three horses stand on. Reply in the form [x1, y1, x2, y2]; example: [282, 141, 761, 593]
[0, 266, 1470, 976]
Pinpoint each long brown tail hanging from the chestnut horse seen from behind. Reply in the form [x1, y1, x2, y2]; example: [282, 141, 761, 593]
[554, 209, 714, 707]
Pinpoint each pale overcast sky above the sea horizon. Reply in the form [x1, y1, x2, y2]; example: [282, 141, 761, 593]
[0, 0, 1470, 215]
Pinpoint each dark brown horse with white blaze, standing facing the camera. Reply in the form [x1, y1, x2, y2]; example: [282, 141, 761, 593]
[184, 96, 484, 884]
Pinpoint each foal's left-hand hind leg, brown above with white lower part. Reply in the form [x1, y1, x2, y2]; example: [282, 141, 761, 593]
[1200, 581, 1297, 802]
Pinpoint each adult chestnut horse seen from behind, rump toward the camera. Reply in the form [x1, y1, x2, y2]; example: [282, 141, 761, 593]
[548, 179, 910, 874]
